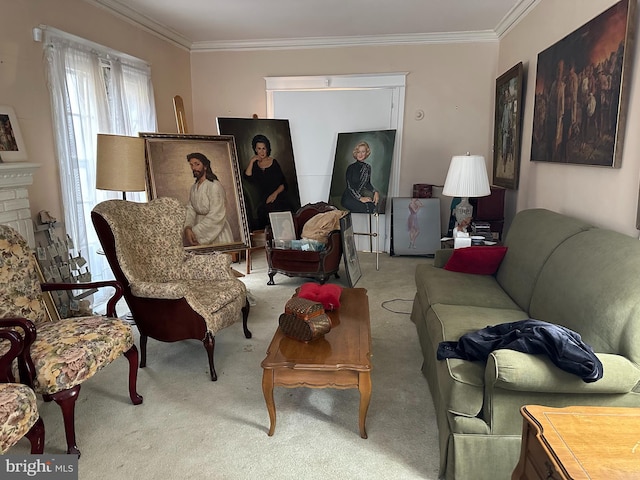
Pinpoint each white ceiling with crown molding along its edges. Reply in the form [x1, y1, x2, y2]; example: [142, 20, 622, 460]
[85, 0, 540, 50]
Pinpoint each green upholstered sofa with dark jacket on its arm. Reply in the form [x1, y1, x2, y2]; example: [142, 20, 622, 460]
[411, 209, 640, 480]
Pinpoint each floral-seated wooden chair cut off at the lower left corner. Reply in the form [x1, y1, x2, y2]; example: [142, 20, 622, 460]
[0, 329, 44, 454]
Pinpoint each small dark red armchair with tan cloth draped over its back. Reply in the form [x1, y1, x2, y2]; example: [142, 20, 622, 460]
[265, 202, 346, 285]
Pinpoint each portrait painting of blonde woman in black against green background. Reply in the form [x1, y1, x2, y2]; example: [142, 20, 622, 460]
[329, 130, 396, 214]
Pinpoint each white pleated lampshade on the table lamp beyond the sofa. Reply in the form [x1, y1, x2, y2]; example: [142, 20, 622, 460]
[442, 155, 491, 197]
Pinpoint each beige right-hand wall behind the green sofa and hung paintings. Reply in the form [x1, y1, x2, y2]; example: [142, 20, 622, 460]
[498, 0, 640, 236]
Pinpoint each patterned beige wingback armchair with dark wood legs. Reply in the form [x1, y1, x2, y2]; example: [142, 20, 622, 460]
[91, 198, 251, 381]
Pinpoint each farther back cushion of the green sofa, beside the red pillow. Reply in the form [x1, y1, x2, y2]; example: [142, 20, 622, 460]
[496, 208, 592, 314]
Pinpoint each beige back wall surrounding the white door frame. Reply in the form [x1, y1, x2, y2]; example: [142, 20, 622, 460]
[192, 42, 498, 200]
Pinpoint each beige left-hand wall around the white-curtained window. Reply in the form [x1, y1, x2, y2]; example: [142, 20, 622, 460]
[0, 0, 191, 219]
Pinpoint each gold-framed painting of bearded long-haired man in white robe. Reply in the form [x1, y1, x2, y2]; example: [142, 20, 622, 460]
[140, 133, 249, 250]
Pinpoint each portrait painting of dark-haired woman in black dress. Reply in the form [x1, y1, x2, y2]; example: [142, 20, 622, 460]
[217, 117, 300, 231]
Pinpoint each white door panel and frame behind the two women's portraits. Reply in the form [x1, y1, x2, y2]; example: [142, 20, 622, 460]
[265, 73, 406, 251]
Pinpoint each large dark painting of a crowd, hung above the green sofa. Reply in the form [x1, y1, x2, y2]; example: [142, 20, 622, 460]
[531, 0, 636, 168]
